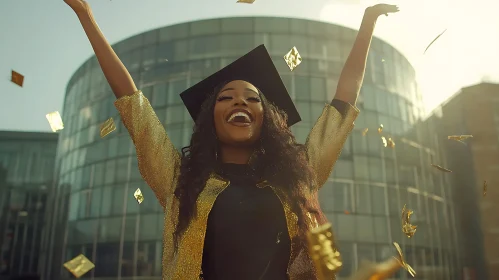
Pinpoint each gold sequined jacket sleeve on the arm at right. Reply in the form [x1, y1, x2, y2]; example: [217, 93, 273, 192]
[305, 99, 359, 188]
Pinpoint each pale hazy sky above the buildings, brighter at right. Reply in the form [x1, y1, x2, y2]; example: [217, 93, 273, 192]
[0, 0, 499, 131]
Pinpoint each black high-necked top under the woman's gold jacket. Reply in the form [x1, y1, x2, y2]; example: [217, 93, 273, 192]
[202, 164, 291, 280]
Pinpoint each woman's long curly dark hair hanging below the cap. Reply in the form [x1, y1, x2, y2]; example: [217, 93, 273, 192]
[174, 82, 316, 248]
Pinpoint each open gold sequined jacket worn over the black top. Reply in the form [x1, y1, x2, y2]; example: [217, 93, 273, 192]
[115, 91, 359, 280]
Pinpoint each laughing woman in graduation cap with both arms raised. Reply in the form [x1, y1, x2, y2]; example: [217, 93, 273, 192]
[65, 0, 398, 280]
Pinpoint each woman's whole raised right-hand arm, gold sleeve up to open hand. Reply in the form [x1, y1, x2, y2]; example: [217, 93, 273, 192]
[305, 4, 398, 188]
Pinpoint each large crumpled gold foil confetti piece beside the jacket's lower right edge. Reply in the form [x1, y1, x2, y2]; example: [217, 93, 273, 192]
[307, 223, 343, 280]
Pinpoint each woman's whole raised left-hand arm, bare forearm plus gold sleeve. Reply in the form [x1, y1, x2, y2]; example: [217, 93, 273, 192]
[64, 0, 180, 208]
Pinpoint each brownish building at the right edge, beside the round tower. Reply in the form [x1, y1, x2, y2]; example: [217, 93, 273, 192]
[426, 83, 499, 279]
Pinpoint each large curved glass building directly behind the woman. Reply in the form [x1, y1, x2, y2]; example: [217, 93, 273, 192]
[44, 17, 460, 280]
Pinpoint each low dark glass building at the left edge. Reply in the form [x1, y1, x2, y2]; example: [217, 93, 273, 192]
[0, 131, 58, 279]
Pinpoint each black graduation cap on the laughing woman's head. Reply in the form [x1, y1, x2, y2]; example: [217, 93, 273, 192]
[180, 45, 301, 126]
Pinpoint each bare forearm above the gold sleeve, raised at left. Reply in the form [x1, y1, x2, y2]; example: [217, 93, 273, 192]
[64, 0, 137, 98]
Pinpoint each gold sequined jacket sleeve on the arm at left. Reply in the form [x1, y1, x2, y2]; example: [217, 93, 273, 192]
[114, 91, 180, 208]
